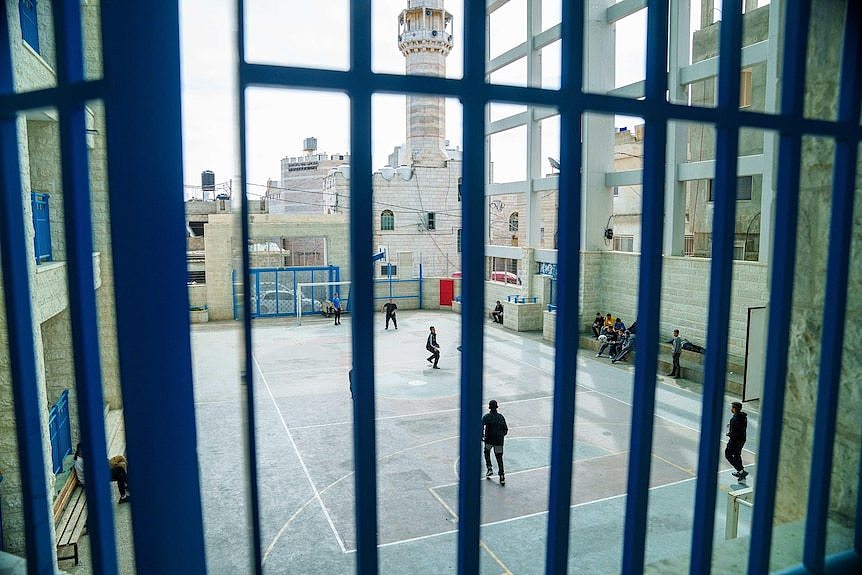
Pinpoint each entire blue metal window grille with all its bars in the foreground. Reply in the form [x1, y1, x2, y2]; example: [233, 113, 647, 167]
[0, 0, 862, 575]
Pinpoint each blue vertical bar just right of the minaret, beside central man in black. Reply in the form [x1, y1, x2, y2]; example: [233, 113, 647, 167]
[458, 2, 487, 575]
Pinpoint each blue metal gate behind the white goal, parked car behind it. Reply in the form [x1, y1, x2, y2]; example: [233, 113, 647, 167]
[238, 266, 350, 319]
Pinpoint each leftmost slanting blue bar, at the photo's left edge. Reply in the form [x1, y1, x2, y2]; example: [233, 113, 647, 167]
[0, 6, 56, 575]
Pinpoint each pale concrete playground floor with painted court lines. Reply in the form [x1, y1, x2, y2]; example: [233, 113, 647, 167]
[66, 311, 758, 574]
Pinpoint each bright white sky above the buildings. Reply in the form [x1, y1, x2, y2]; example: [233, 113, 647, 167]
[180, 0, 656, 194]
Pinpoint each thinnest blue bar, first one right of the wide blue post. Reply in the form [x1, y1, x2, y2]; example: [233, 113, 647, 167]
[236, 0, 264, 575]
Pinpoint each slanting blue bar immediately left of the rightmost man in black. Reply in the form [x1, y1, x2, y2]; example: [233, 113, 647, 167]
[689, 0, 742, 575]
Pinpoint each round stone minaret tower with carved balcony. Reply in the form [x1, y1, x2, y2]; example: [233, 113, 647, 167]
[398, 0, 452, 167]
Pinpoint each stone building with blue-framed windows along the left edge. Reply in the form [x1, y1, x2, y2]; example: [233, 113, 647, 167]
[0, 0, 122, 554]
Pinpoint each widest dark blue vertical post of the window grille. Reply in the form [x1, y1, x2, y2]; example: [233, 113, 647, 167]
[101, 0, 205, 575]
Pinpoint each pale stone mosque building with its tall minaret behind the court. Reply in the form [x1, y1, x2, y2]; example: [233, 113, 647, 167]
[324, 0, 461, 277]
